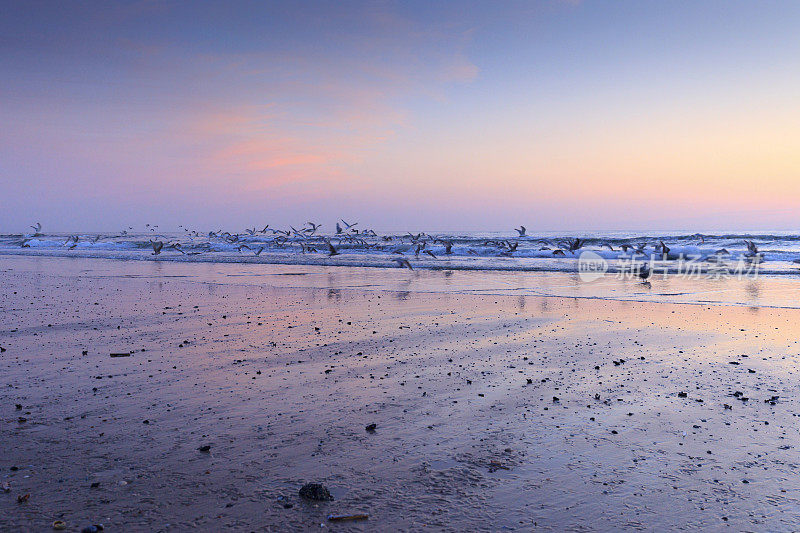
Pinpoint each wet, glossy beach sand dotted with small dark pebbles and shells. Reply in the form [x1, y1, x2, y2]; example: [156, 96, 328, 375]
[0, 257, 800, 531]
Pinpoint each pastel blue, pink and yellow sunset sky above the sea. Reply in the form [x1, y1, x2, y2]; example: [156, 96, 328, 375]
[0, 0, 800, 233]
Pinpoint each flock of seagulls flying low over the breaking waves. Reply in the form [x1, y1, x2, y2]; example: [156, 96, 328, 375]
[17, 220, 776, 278]
